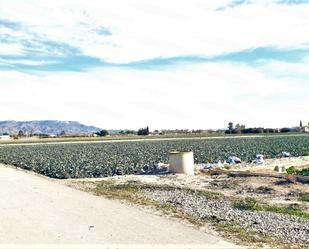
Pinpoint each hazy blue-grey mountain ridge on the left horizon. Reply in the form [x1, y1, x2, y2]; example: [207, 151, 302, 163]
[0, 120, 101, 135]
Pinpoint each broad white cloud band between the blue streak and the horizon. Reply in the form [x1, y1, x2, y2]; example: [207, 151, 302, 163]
[0, 63, 309, 129]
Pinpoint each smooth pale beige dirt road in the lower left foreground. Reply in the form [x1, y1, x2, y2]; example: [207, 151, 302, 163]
[0, 165, 237, 248]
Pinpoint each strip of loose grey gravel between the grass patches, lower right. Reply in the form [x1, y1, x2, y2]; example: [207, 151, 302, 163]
[142, 188, 309, 244]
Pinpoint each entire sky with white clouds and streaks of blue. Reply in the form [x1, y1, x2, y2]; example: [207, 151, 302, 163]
[0, 0, 309, 130]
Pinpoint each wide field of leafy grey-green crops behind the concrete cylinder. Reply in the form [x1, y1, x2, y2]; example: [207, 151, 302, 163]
[0, 135, 309, 179]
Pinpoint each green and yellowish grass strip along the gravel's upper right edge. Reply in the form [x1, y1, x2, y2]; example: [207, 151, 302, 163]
[233, 198, 309, 220]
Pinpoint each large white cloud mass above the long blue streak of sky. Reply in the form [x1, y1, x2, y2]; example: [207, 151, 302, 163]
[0, 0, 309, 63]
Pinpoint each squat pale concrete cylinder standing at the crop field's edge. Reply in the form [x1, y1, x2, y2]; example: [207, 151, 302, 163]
[169, 151, 194, 175]
